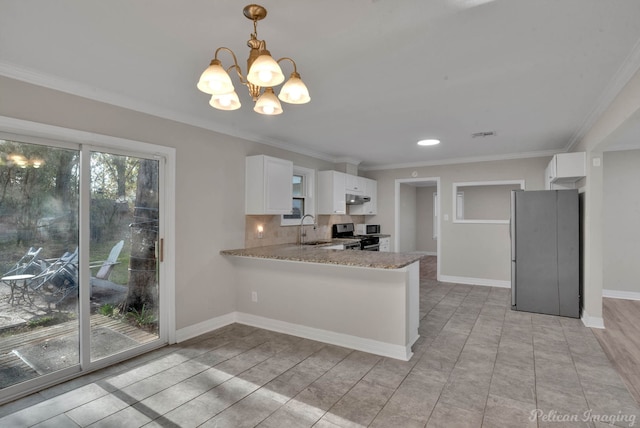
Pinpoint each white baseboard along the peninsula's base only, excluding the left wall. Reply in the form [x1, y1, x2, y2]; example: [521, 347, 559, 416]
[236, 312, 419, 361]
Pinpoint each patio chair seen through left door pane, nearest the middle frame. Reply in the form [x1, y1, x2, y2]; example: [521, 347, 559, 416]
[29, 248, 78, 305]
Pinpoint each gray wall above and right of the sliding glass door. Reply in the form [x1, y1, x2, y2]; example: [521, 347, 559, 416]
[0, 77, 334, 329]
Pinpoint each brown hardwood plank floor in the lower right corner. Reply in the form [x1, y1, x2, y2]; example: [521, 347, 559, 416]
[592, 298, 640, 404]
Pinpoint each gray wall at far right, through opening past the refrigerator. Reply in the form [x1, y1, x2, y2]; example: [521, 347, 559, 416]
[602, 150, 640, 293]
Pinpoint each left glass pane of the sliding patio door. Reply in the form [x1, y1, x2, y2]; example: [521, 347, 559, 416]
[0, 140, 80, 388]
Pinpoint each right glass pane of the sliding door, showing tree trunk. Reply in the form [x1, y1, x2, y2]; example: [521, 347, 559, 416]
[89, 151, 160, 361]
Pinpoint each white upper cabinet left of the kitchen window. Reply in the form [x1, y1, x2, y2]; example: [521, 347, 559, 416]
[245, 155, 293, 214]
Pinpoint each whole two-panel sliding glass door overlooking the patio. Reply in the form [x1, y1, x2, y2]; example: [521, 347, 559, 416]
[0, 139, 166, 404]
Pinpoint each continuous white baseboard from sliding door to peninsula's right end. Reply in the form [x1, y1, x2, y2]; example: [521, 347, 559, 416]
[176, 312, 420, 361]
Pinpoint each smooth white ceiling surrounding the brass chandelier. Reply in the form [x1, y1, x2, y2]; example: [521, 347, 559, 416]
[0, 0, 640, 169]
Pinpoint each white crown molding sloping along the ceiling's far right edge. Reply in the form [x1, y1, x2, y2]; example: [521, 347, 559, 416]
[566, 35, 640, 152]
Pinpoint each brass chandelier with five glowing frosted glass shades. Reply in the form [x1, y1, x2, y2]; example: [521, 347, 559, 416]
[197, 4, 311, 115]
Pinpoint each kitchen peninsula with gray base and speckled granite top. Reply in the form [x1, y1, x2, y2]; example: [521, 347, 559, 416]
[220, 244, 422, 360]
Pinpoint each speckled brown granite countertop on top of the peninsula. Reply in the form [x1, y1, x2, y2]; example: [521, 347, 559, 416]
[220, 242, 424, 269]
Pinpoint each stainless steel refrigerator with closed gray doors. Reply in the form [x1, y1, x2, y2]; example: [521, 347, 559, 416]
[510, 189, 580, 318]
